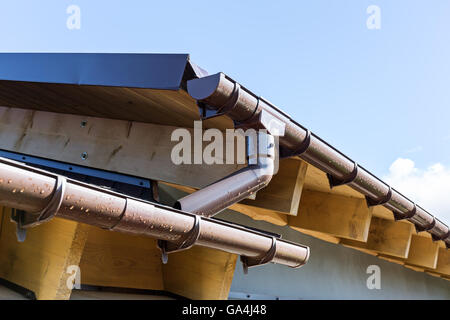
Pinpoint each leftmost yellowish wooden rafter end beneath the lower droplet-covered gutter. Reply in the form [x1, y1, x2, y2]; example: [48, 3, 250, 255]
[0, 208, 88, 299]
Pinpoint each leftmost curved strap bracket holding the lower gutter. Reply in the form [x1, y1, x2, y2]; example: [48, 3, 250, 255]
[11, 175, 67, 242]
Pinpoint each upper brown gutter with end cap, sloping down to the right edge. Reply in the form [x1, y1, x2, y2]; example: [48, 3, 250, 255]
[187, 73, 450, 248]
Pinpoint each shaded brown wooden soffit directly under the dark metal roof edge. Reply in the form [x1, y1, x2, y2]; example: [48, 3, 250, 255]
[0, 81, 233, 129]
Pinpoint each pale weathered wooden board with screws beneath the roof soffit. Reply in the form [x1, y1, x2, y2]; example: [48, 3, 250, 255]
[0, 107, 245, 188]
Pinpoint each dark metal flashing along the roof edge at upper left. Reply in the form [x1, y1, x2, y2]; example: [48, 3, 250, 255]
[0, 53, 189, 90]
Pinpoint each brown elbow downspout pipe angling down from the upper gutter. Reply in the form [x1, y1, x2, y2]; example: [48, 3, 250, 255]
[175, 131, 275, 217]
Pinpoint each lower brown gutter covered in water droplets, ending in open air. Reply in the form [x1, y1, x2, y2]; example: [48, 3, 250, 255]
[0, 158, 309, 268]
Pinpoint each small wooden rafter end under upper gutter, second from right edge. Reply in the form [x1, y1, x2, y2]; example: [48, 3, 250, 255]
[405, 235, 439, 269]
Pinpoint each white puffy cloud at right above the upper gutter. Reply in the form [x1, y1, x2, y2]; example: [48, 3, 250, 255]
[384, 158, 450, 225]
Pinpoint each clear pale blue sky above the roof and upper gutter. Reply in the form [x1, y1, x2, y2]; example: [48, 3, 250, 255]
[0, 0, 450, 180]
